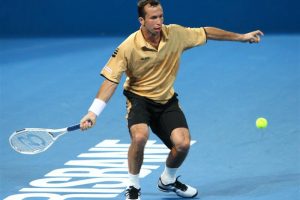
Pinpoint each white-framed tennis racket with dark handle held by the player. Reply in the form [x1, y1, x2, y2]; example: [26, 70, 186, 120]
[9, 124, 80, 154]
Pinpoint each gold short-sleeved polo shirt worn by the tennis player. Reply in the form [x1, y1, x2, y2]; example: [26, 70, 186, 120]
[101, 24, 206, 103]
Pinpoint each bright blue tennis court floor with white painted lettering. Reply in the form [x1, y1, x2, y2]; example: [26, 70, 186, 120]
[0, 34, 300, 200]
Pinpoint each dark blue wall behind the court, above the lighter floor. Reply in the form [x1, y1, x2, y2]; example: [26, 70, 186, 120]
[0, 0, 300, 37]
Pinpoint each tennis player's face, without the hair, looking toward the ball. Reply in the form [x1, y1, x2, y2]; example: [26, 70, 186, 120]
[140, 4, 164, 35]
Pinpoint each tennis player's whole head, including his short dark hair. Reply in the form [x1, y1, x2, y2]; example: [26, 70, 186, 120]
[138, 0, 164, 35]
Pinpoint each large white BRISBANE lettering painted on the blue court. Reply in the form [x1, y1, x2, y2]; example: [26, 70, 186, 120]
[4, 140, 195, 200]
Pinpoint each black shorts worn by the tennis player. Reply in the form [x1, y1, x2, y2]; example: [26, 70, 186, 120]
[123, 90, 188, 149]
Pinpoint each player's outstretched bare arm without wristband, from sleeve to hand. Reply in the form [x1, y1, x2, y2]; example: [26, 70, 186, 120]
[204, 27, 264, 43]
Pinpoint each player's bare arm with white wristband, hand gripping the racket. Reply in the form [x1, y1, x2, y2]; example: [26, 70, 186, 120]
[80, 79, 118, 130]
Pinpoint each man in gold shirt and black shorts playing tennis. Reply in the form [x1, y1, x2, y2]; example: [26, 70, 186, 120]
[80, 0, 263, 200]
